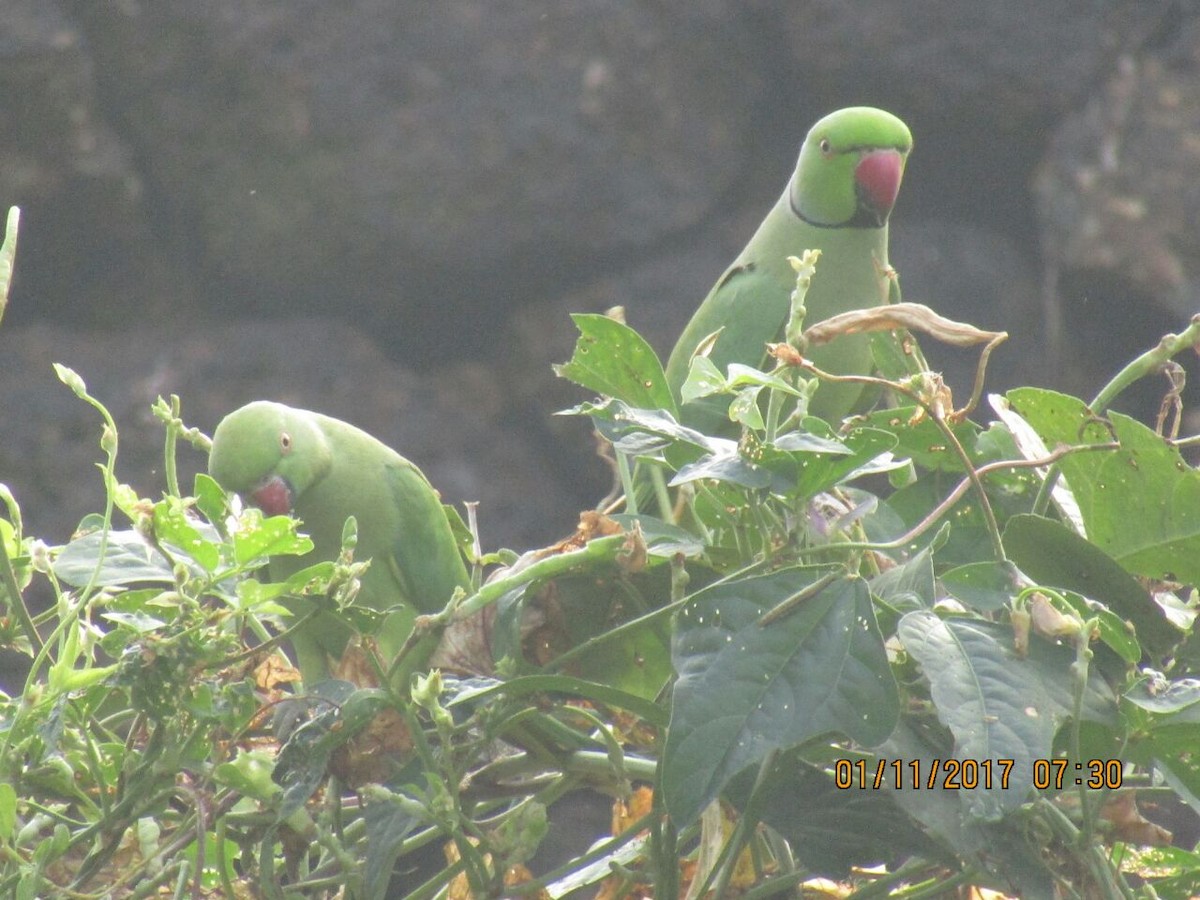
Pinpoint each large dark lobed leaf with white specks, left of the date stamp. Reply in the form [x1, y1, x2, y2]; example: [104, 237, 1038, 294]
[662, 568, 899, 827]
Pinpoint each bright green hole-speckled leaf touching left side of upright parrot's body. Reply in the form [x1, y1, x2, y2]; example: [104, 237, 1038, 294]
[554, 313, 676, 413]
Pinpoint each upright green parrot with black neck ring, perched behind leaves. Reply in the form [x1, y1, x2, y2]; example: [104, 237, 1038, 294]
[666, 107, 912, 431]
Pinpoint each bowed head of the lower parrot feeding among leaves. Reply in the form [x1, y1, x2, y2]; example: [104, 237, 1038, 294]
[209, 401, 332, 516]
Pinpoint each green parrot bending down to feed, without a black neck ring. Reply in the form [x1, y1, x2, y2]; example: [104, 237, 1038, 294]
[209, 401, 469, 685]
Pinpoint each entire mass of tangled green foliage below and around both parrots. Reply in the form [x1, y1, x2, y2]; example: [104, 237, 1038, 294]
[7, 204, 1200, 899]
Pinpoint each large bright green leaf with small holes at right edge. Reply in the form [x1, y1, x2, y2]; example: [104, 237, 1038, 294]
[1007, 388, 1200, 584]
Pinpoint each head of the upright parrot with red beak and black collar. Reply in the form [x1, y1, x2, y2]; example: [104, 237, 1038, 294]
[788, 107, 912, 228]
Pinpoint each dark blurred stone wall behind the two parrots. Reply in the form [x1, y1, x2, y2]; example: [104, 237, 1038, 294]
[0, 0, 1200, 548]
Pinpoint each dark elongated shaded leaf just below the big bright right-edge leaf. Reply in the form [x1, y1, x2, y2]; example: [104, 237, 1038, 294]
[1003, 515, 1182, 655]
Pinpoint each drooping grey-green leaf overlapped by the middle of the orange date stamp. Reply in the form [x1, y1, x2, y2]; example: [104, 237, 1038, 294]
[896, 610, 1115, 821]
